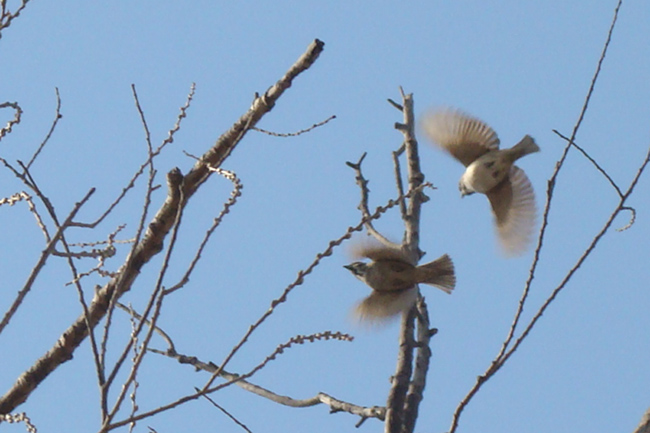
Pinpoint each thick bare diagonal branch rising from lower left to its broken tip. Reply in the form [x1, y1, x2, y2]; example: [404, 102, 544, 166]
[0, 40, 324, 414]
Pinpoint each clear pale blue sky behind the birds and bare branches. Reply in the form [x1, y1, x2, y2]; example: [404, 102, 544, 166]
[0, 0, 650, 433]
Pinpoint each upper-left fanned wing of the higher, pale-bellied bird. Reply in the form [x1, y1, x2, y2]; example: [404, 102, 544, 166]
[421, 109, 499, 167]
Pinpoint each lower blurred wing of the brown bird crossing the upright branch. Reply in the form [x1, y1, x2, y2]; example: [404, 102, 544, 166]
[354, 286, 418, 323]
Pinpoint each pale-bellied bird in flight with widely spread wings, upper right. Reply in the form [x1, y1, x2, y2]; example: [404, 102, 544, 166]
[421, 109, 540, 256]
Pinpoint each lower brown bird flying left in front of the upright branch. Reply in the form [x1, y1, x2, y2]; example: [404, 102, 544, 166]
[344, 245, 456, 322]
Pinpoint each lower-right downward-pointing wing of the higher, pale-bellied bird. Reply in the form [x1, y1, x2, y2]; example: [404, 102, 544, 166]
[486, 165, 537, 256]
